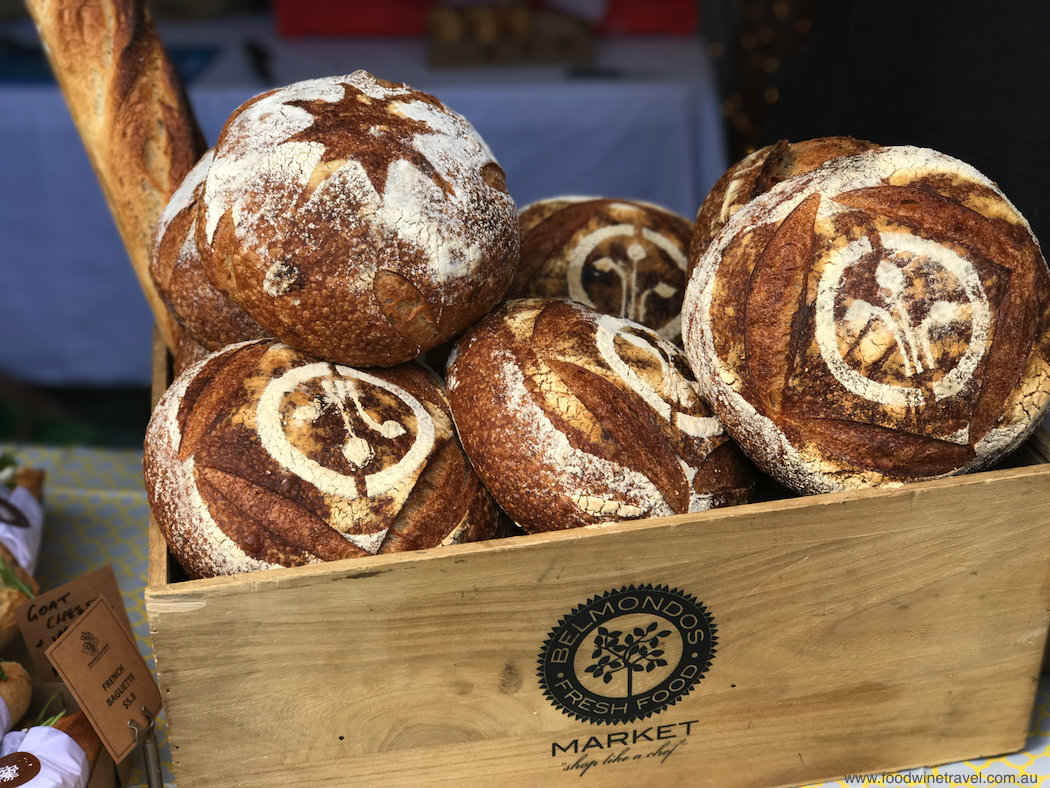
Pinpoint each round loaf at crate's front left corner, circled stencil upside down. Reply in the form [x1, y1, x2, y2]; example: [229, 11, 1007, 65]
[143, 340, 504, 578]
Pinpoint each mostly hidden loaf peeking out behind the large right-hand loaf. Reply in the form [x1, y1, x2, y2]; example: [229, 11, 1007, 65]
[689, 137, 878, 271]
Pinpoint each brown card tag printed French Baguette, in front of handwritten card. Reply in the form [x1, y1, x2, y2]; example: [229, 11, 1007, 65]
[47, 597, 161, 763]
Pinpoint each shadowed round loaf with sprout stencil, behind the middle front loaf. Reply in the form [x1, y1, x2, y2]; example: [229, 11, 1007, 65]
[507, 196, 693, 343]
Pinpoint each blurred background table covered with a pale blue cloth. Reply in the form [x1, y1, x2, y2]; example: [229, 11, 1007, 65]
[0, 16, 727, 386]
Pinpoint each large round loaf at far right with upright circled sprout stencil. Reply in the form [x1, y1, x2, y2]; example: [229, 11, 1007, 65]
[683, 147, 1050, 493]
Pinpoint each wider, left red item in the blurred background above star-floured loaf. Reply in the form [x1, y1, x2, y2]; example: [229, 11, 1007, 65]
[273, 0, 435, 38]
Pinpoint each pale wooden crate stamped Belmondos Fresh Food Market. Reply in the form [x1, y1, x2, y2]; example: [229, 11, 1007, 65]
[146, 334, 1050, 788]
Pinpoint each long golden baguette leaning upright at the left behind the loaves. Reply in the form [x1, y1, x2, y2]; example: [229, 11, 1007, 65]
[26, 0, 206, 349]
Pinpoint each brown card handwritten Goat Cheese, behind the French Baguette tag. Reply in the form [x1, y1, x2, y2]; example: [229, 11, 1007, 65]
[15, 564, 131, 681]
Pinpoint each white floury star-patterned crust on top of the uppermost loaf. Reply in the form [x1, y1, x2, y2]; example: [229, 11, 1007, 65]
[205, 71, 503, 278]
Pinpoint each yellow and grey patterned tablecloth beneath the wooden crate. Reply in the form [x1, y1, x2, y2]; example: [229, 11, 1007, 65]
[0, 443, 1050, 788]
